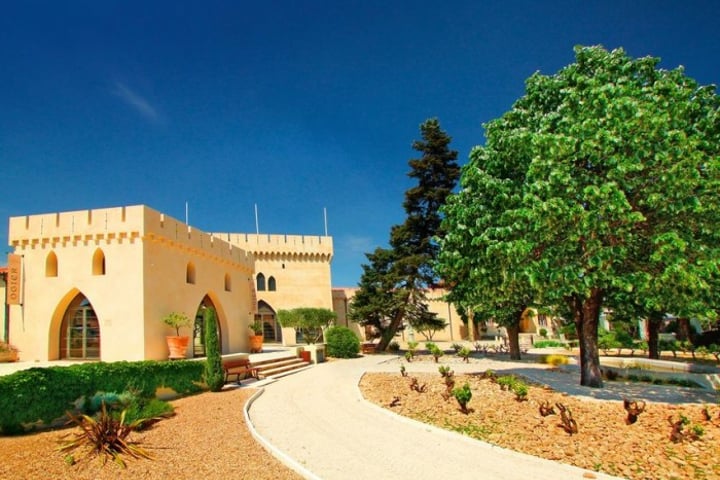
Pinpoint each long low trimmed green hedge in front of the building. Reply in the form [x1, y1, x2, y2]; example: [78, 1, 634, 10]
[0, 360, 204, 435]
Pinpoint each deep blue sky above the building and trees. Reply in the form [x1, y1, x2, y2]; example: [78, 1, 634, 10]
[0, 0, 720, 286]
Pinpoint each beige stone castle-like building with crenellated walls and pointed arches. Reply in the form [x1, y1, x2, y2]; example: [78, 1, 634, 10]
[3, 205, 333, 361]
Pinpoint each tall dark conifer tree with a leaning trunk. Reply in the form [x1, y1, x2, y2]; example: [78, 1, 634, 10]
[350, 118, 460, 350]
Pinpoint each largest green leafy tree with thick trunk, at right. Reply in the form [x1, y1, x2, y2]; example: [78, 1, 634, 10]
[442, 47, 720, 387]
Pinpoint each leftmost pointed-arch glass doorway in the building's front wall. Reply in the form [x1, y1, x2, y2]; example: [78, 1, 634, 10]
[60, 293, 100, 360]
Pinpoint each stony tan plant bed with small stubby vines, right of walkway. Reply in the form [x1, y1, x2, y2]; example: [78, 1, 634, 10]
[360, 373, 720, 480]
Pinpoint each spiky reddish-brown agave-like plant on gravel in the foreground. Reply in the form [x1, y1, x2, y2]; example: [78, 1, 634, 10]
[58, 402, 153, 468]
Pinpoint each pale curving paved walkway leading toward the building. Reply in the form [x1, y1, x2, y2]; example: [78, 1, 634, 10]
[248, 355, 616, 480]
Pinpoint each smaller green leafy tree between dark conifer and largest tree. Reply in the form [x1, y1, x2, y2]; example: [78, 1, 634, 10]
[437, 102, 535, 359]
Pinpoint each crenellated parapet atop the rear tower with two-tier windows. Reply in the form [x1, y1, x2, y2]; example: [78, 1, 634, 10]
[214, 233, 333, 263]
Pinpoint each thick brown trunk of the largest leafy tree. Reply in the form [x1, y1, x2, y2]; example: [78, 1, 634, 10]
[571, 288, 603, 388]
